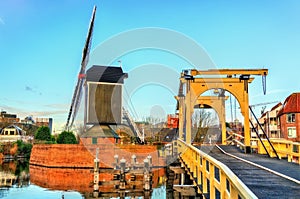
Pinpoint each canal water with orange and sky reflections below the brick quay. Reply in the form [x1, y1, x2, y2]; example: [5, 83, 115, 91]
[0, 160, 167, 199]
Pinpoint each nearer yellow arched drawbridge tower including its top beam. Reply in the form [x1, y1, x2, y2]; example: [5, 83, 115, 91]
[177, 69, 268, 153]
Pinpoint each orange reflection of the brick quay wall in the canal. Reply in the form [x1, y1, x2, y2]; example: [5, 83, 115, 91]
[30, 165, 165, 198]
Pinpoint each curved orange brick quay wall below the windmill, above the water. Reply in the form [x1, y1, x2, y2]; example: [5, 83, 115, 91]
[30, 143, 165, 168]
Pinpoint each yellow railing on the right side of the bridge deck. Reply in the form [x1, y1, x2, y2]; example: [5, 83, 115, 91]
[251, 138, 300, 164]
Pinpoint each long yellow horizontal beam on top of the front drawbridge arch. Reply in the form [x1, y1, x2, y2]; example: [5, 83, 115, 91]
[191, 69, 268, 76]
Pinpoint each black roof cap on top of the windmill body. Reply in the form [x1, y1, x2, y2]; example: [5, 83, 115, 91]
[86, 65, 128, 84]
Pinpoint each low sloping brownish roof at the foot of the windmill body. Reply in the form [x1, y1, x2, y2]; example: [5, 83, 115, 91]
[81, 125, 119, 138]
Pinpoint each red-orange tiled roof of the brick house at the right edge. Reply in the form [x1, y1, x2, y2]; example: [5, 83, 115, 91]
[278, 93, 300, 116]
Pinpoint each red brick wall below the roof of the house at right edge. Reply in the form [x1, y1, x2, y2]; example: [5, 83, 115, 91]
[280, 113, 300, 142]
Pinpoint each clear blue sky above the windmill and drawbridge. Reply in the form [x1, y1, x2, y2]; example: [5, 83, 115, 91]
[0, 0, 300, 130]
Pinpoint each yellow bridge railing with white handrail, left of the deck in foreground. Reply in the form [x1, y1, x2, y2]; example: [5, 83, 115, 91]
[174, 140, 257, 199]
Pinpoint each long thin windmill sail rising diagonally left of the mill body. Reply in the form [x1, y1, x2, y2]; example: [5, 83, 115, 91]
[65, 6, 97, 129]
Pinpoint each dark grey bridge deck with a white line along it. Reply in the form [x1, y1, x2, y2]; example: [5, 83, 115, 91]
[200, 146, 300, 198]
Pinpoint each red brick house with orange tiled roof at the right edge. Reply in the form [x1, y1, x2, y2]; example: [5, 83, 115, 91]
[277, 93, 300, 142]
